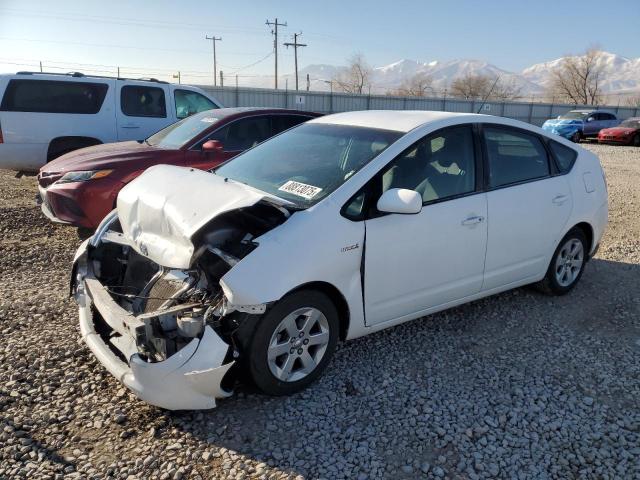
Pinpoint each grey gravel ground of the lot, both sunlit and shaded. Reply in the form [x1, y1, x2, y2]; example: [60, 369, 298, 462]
[0, 145, 640, 479]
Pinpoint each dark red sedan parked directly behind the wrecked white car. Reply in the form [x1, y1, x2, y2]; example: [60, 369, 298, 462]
[38, 108, 319, 230]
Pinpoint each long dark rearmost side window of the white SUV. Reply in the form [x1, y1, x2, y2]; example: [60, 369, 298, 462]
[0, 80, 109, 114]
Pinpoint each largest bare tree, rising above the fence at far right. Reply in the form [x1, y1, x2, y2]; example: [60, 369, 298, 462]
[550, 48, 604, 105]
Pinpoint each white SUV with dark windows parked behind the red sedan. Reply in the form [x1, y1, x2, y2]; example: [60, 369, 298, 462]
[0, 72, 221, 171]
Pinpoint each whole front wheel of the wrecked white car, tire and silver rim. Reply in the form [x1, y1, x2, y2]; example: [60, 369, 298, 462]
[248, 290, 339, 395]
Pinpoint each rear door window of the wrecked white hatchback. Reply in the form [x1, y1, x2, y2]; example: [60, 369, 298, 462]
[484, 127, 549, 188]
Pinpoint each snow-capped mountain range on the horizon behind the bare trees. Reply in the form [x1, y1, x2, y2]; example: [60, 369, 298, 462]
[242, 52, 640, 97]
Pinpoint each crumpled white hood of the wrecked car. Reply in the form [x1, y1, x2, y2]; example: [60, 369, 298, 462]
[117, 165, 287, 269]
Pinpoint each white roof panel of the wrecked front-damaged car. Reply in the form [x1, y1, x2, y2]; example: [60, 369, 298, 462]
[310, 110, 487, 133]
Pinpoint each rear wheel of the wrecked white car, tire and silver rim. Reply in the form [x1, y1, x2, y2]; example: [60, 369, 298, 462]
[540, 228, 588, 295]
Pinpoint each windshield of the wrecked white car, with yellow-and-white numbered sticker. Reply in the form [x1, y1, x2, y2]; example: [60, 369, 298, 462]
[215, 123, 403, 208]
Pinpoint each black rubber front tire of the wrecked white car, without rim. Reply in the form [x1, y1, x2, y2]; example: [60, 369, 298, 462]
[245, 290, 339, 396]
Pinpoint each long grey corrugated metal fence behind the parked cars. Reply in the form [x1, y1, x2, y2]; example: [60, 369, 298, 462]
[200, 85, 640, 125]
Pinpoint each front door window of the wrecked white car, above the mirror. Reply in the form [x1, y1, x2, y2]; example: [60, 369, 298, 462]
[382, 126, 475, 203]
